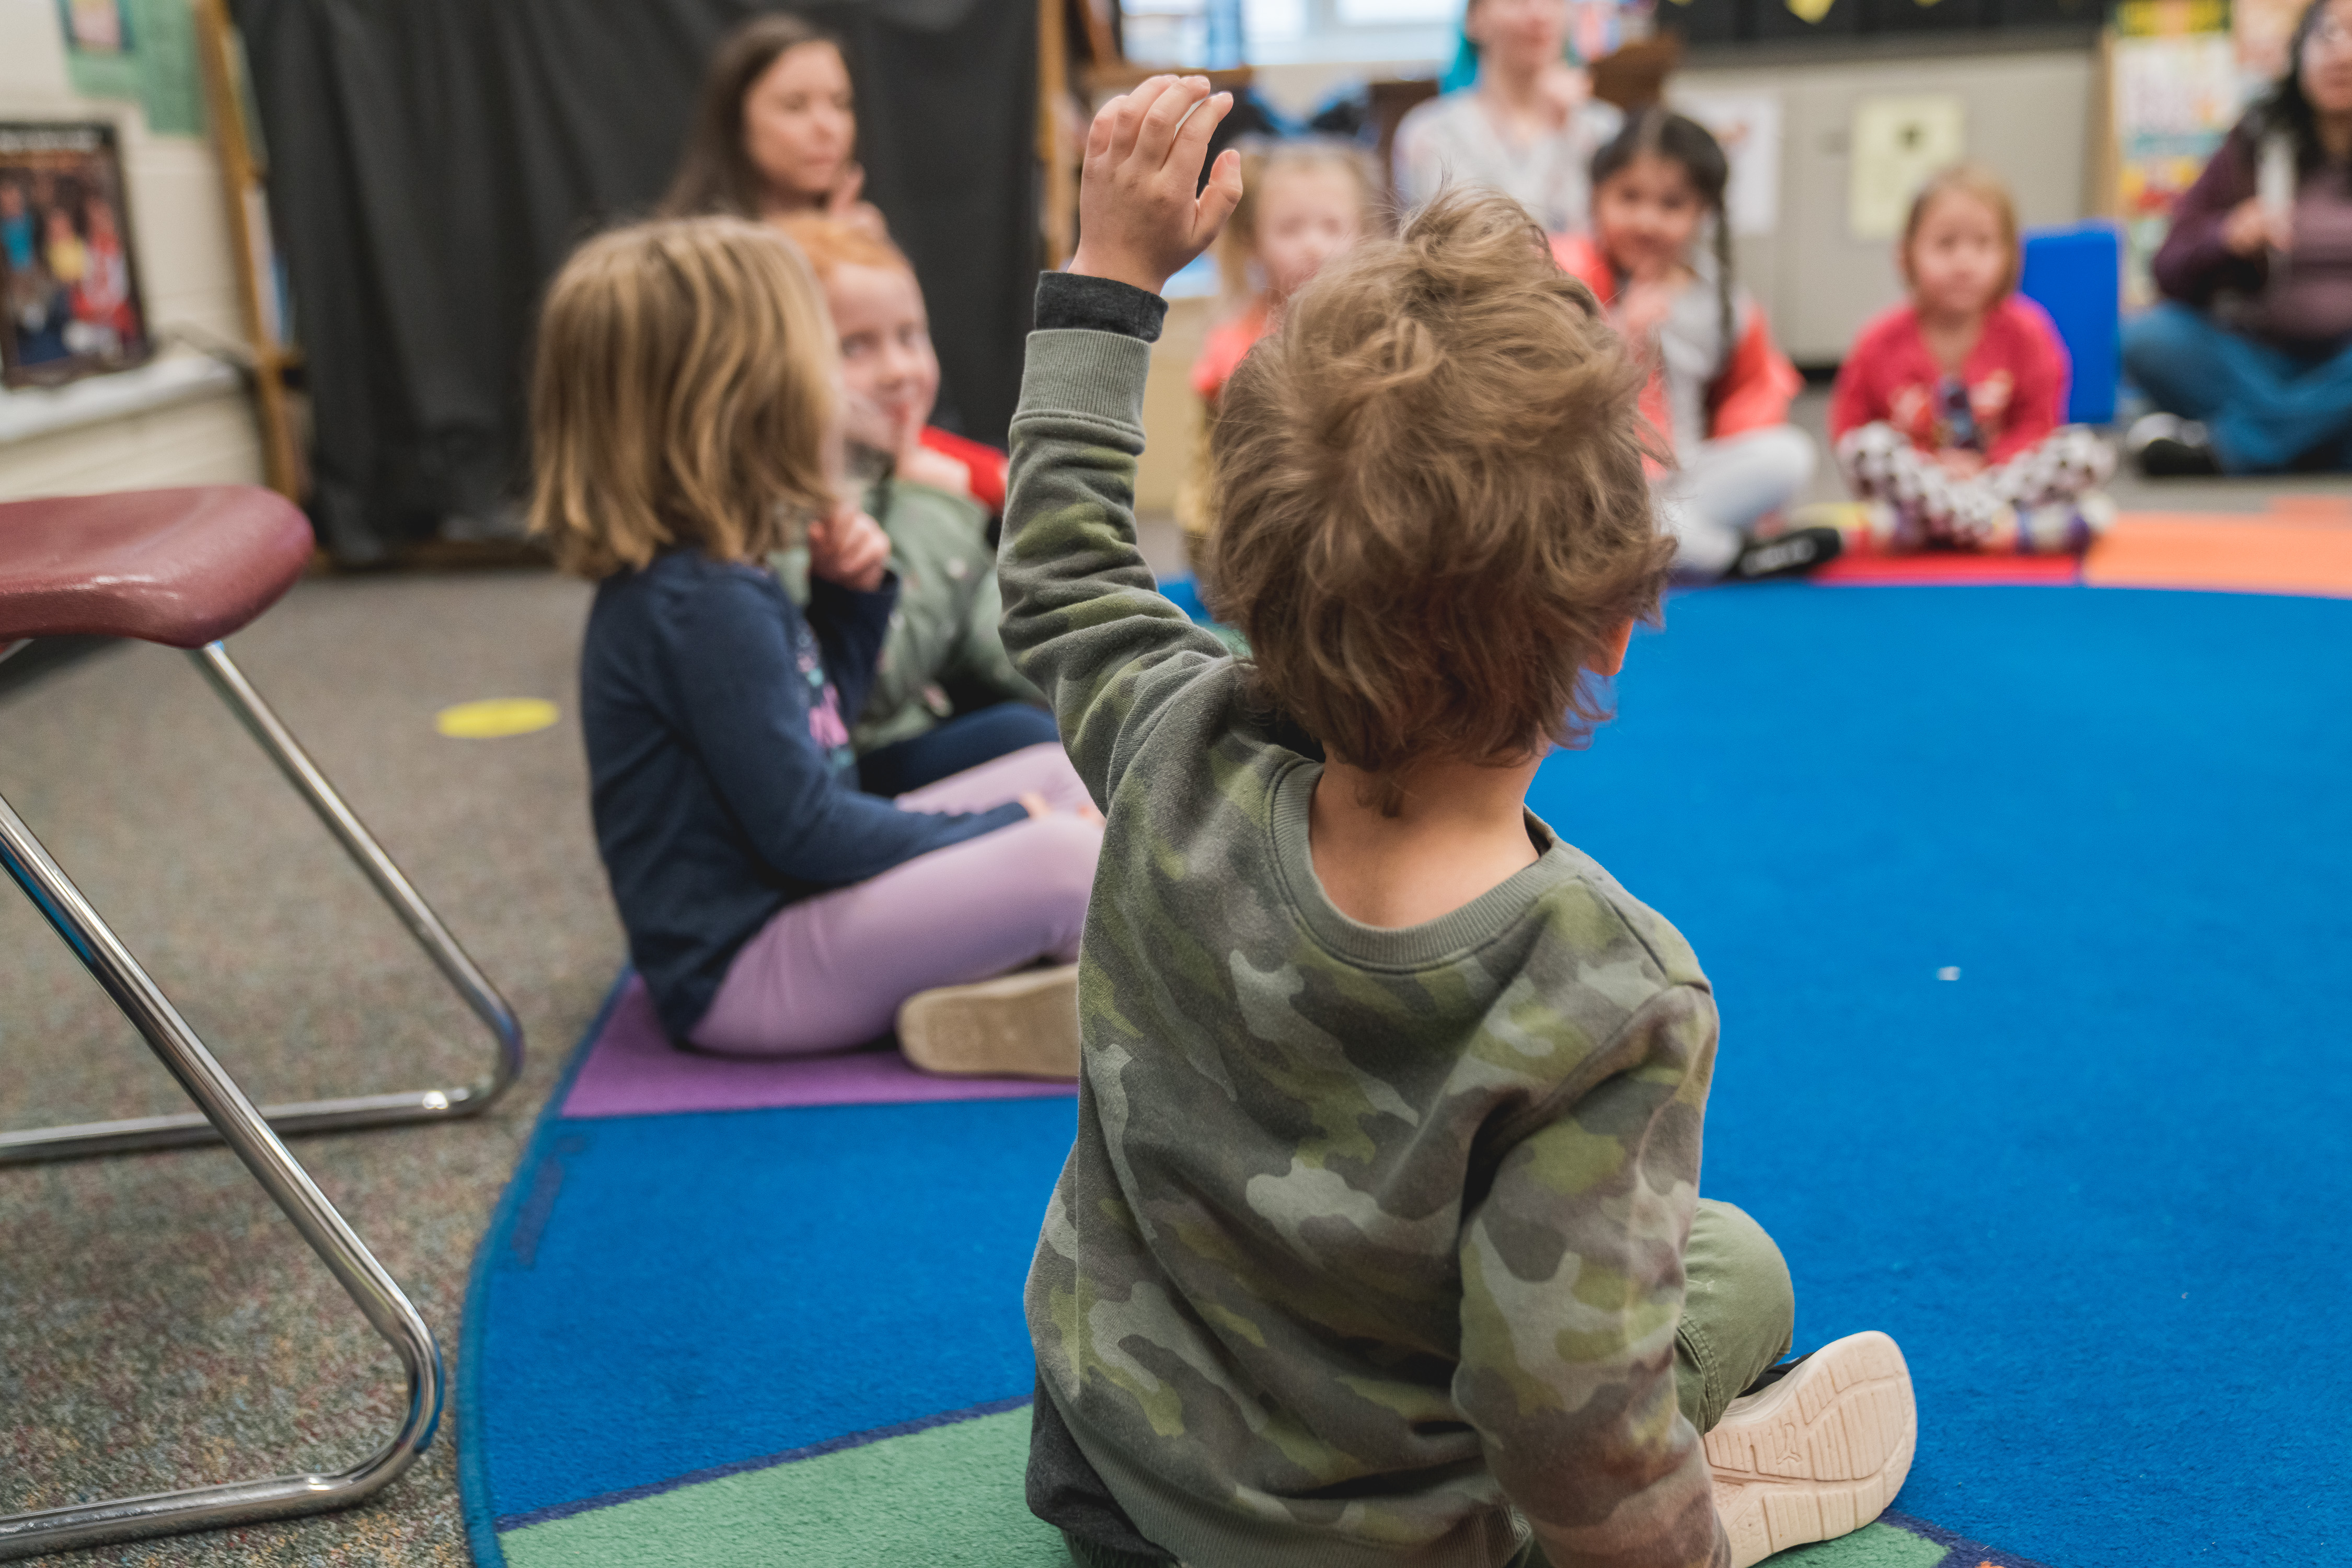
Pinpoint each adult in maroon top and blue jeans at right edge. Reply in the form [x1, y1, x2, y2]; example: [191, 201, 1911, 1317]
[2124, 0, 2352, 477]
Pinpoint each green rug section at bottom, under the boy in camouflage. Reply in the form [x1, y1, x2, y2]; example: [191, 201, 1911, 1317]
[499, 1408, 1974, 1568]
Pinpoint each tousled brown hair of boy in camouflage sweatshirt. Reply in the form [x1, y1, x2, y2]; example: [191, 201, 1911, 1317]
[1209, 193, 1675, 811]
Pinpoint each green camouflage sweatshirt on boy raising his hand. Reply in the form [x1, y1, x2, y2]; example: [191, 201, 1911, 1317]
[1000, 275, 1729, 1568]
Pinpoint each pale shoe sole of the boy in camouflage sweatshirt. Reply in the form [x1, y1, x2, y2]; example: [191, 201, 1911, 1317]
[1705, 1331, 1919, 1568]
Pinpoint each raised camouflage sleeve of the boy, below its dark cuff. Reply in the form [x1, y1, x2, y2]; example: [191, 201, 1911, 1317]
[997, 327, 1230, 809]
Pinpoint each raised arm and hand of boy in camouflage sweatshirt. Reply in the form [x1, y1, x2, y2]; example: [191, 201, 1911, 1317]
[997, 77, 1242, 806]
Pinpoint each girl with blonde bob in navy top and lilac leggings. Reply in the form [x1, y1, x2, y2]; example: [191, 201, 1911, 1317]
[532, 216, 1101, 1074]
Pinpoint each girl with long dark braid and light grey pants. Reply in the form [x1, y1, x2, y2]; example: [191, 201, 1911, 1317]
[1552, 108, 1839, 581]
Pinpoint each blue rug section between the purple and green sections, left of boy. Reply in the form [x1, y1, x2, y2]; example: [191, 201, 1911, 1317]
[466, 1100, 1075, 1521]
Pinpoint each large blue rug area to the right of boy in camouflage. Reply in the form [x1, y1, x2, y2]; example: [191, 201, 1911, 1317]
[1534, 587, 2352, 1568]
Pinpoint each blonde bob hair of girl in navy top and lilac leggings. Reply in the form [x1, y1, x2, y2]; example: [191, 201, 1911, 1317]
[532, 216, 837, 578]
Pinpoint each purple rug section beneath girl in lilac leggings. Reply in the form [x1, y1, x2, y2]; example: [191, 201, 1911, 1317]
[564, 976, 1077, 1116]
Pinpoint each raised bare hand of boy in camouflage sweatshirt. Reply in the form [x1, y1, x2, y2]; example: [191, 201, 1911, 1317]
[1070, 75, 1242, 294]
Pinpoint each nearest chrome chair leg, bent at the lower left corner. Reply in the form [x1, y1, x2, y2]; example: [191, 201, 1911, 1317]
[0, 799, 442, 1559]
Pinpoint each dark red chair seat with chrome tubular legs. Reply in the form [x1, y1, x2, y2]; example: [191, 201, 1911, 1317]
[0, 487, 522, 1559]
